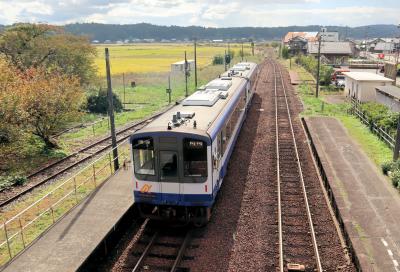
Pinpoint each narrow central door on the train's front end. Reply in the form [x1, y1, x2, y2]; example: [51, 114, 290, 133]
[158, 137, 181, 205]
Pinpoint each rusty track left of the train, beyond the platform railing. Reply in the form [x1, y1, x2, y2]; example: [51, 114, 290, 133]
[0, 107, 170, 208]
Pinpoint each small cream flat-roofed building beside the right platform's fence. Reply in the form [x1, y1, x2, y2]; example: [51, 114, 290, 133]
[343, 72, 393, 102]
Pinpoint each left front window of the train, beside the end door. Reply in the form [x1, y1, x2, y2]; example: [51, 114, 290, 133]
[132, 138, 155, 175]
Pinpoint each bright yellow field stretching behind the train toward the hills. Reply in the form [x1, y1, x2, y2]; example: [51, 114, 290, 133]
[95, 43, 250, 75]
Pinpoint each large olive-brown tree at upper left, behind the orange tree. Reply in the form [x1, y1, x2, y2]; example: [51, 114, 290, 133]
[0, 24, 96, 84]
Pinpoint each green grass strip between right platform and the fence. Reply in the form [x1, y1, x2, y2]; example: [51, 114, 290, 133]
[284, 61, 393, 169]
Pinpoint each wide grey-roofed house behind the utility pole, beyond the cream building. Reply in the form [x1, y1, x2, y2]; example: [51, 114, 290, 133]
[307, 42, 353, 64]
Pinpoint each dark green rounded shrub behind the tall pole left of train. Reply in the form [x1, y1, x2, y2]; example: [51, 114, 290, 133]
[86, 90, 123, 114]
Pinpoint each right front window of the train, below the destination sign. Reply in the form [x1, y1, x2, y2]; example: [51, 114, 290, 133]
[183, 139, 207, 177]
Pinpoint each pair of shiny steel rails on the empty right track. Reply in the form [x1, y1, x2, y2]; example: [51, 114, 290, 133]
[273, 61, 323, 272]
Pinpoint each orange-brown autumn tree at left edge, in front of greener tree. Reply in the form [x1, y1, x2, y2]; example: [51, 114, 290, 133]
[0, 61, 83, 148]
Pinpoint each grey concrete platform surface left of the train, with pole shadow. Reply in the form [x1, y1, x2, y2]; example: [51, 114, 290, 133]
[3, 167, 133, 272]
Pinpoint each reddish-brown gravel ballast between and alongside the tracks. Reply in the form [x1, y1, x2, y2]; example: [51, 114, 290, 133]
[97, 55, 355, 272]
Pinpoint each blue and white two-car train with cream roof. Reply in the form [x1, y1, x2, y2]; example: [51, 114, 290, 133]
[130, 62, 258, 225]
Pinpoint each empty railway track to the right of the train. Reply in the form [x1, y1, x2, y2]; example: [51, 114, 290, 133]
[273, 64, 323, 272]
